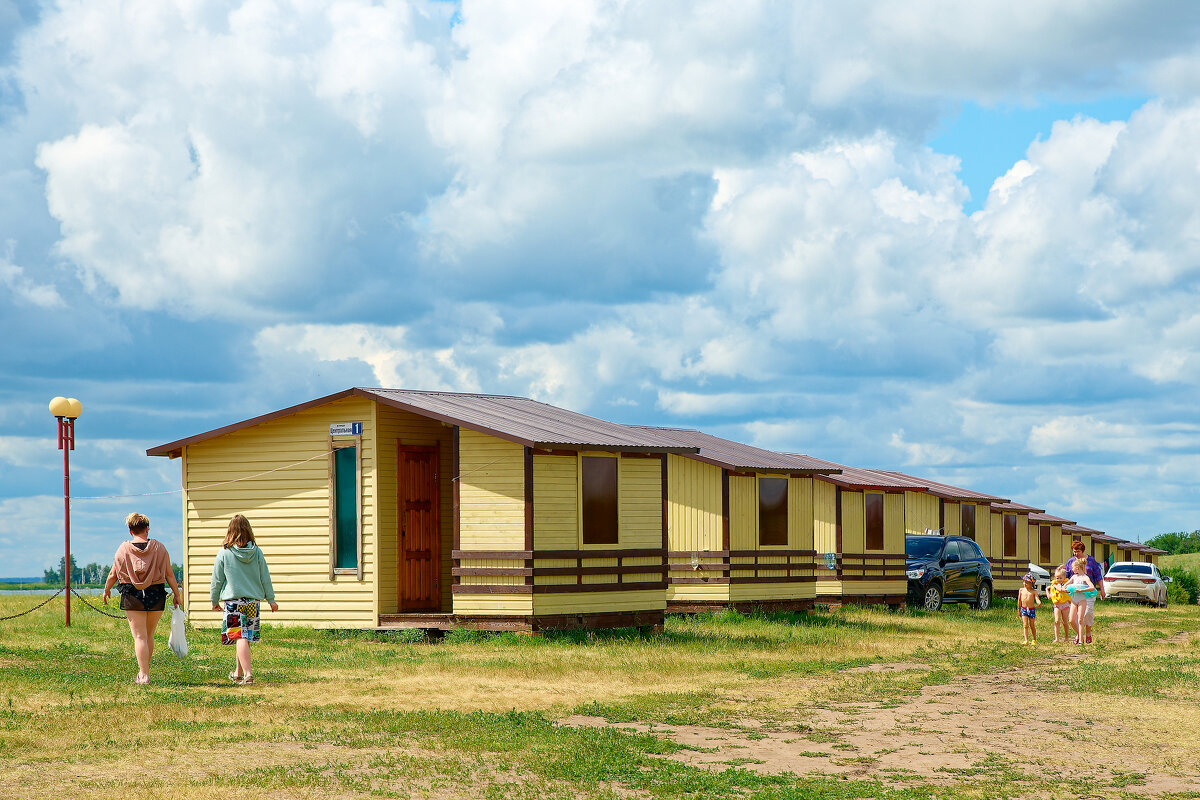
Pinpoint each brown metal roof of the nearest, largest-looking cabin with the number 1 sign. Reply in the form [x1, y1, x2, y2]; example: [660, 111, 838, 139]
[146, 389, 696, 456]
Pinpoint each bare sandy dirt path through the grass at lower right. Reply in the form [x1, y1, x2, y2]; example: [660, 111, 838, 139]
[562, 655, 1200, 798]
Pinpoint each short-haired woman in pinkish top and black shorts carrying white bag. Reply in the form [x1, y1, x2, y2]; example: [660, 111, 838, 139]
[104, 513, 181, 685]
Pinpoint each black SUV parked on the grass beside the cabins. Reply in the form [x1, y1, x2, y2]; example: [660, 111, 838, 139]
[904, 535, 991, 612]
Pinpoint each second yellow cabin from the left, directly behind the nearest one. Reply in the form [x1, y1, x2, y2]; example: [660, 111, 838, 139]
[624, 428, 839, 613]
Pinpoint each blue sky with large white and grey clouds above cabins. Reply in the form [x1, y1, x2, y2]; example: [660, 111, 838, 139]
[0, 0, 1200, 576]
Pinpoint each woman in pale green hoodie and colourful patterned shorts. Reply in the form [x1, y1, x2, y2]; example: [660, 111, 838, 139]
[209, 513, 280, 685]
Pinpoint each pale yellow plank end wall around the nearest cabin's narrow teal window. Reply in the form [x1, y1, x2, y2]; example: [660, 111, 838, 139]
[184, 397, 379, 627]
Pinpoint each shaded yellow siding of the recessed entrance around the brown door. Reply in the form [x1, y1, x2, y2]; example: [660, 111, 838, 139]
[376, 404, 455, 614]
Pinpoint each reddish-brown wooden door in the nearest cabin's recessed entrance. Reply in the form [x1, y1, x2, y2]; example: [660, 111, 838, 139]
[396, 445, 442, 612]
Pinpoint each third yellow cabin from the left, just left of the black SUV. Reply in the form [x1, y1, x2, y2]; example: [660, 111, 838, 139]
[796, 458, 907, 608]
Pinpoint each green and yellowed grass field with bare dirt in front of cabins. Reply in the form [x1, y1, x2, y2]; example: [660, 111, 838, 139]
[0, 595, 1200, 800]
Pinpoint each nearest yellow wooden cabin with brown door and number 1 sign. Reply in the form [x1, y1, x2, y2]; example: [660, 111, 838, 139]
[148, 389, 696, 630]
